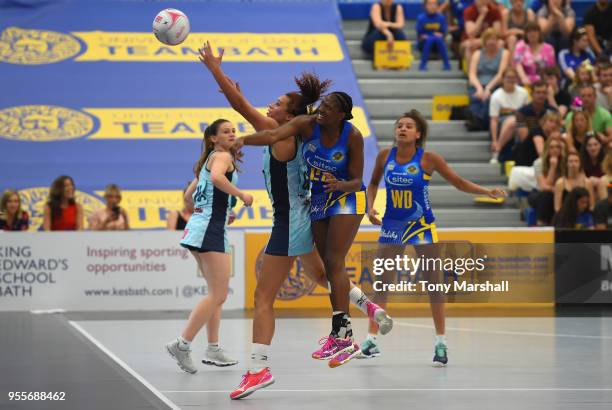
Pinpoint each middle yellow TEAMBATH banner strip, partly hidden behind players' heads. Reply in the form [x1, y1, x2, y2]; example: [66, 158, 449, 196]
[0, 105, 371, 142]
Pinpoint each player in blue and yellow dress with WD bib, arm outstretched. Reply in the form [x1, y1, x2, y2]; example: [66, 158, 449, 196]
[361, 110, 505, 366]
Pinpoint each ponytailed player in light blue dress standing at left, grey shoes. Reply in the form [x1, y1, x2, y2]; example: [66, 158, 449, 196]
[165, 119, 253, 373]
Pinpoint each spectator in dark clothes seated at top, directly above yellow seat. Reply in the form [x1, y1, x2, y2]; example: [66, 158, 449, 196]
[361, 0, 406, 55]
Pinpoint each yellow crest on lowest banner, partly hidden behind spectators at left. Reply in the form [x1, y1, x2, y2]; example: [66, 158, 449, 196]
[19, 187, 105, 231]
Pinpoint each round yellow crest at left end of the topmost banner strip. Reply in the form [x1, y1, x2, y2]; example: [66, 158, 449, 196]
[0, 27, 81, 65]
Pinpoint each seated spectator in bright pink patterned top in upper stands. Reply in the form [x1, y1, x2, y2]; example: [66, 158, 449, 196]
[513, 23, 556, 87]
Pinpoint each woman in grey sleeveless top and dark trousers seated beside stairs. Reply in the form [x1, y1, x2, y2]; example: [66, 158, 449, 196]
[468, 28, 510, 130]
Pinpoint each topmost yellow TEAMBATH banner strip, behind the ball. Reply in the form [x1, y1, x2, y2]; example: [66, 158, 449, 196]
[0, 27, 344, 64]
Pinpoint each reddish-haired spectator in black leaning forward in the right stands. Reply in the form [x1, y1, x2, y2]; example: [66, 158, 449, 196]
[514, 111, 562, 167]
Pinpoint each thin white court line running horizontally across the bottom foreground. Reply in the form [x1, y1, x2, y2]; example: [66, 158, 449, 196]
[162, 387, 612, 393]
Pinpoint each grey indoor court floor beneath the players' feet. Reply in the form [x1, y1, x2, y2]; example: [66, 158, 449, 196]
[0, 312, 612, 410]
